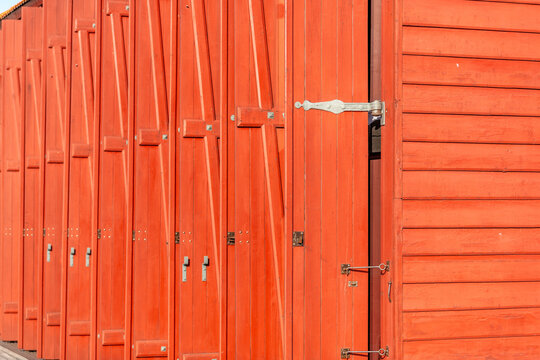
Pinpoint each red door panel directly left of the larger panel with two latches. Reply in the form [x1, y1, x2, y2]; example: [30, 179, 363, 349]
[128, 0, 176, 358]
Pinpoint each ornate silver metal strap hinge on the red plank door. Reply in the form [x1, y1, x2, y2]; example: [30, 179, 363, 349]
[294, 100, 386, 125]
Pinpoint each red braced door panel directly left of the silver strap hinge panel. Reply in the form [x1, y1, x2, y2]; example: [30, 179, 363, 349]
[228, 0, 285, 360]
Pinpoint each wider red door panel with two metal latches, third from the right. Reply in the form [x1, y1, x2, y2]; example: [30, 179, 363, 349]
[176, 0, 222, 360]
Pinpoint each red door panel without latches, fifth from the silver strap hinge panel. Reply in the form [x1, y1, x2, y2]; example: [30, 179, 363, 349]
[95, 0, 133, 360]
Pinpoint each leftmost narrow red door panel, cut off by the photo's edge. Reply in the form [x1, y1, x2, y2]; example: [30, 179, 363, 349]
[1, 20, 23, 341]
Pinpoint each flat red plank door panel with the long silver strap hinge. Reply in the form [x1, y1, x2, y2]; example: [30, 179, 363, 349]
[287, 0, 372, 359]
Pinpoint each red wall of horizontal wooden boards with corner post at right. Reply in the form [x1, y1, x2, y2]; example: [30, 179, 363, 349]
[382, 0, 540, 360]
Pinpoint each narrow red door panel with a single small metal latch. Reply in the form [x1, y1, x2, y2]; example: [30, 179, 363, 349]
[38, 0, 69, 359]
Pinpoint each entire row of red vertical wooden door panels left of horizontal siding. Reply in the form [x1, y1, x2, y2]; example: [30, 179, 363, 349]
[0, 0, 378, 360]
